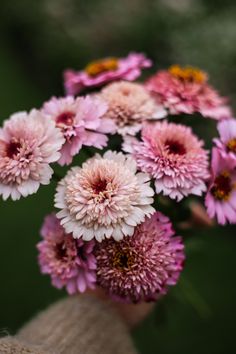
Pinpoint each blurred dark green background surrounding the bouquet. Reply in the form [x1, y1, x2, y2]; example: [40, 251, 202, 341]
[0, 0, 236, 354]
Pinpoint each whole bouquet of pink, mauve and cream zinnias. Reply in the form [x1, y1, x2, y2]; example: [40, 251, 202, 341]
[0, 53, 236, 303]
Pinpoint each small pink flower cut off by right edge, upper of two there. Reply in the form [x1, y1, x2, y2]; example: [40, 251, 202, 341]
[214, 119, 236, 161]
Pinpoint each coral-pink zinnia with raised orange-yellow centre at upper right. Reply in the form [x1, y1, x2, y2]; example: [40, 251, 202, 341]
[146, 65, 232, 120]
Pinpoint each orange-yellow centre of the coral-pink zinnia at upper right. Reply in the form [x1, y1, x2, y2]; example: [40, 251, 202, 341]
[169, 65, 207, 84]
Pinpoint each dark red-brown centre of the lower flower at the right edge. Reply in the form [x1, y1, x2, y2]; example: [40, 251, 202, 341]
[211, 171, 233, 201]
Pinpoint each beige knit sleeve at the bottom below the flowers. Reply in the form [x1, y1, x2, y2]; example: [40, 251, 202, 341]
[0, 295, 137, 354]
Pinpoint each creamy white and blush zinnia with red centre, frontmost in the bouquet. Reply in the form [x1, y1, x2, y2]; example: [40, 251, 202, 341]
[55, 151, 154, 241]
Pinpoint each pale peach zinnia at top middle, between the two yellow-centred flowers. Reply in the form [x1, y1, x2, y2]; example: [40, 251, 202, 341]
[100, 81, 167, 135]
